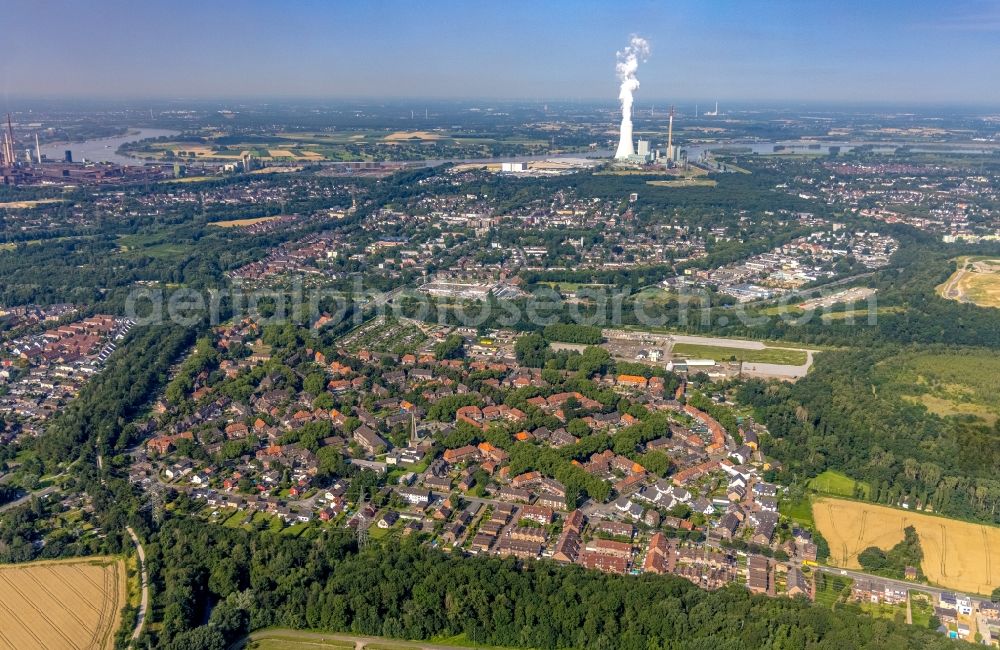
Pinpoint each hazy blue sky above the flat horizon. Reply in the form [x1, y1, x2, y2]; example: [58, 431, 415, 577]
[7, 0, 1000, 106]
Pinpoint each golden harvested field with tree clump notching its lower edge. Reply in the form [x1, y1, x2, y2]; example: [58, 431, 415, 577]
[813, 498, 1000, 594]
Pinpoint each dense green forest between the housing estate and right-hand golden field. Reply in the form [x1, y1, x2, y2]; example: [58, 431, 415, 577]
[737, 345, 1000, 524]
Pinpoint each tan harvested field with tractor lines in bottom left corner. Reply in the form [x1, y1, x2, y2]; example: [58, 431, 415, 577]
[0, 557, 126, 650]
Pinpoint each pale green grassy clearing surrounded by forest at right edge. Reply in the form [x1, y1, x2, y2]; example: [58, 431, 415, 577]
[876, 350, 1000, 425]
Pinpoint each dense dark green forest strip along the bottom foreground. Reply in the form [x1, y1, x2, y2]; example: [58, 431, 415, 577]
[147, 519, 952, 650]
